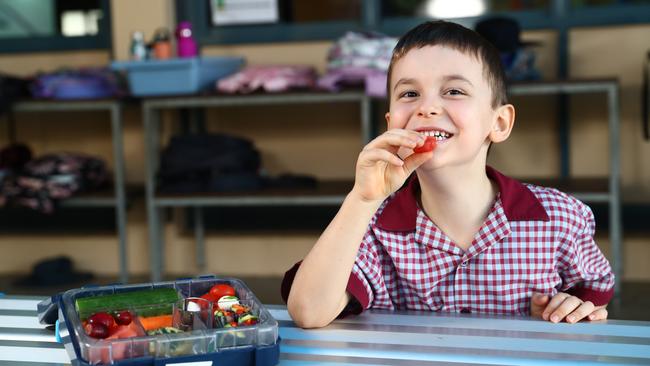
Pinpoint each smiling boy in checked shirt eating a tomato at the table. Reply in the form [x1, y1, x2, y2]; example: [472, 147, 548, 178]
[283, 21, 614, 328]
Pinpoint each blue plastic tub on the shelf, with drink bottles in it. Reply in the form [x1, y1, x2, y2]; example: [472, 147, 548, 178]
[111, 56, 244, 96]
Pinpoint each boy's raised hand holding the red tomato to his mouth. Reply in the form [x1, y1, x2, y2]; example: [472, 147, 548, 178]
[352, 129, 433, 202]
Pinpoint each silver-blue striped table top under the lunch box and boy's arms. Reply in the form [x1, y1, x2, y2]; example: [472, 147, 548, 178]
[0, 296, 650, 366]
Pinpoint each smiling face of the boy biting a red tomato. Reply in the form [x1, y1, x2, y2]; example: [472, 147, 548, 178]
[386, 46, 514, 168]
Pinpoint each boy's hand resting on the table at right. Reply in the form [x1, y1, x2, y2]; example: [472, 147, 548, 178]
[530, 292, 607, 323]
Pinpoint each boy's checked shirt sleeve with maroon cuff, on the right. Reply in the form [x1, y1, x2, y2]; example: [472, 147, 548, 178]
[558, 198, 614, 306]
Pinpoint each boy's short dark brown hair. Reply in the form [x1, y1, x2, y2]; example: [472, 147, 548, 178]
[387, 20, 508, 108]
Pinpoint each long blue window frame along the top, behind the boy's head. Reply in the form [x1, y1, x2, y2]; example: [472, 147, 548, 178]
[176, 0, 650, 46]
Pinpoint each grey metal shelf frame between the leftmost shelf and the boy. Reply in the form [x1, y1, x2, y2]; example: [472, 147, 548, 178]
[142, 91, 372, 281]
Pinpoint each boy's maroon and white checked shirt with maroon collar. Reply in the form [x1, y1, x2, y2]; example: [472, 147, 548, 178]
[282, 167, 614, 315]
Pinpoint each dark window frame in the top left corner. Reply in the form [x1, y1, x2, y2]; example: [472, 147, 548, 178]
[0, 0, 113, 54]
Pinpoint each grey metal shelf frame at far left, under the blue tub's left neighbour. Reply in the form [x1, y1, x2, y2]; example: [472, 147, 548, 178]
[13, 99, 129, 283]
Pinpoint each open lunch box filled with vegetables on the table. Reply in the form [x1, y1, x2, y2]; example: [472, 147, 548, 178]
[39, 276, 280, 366]
